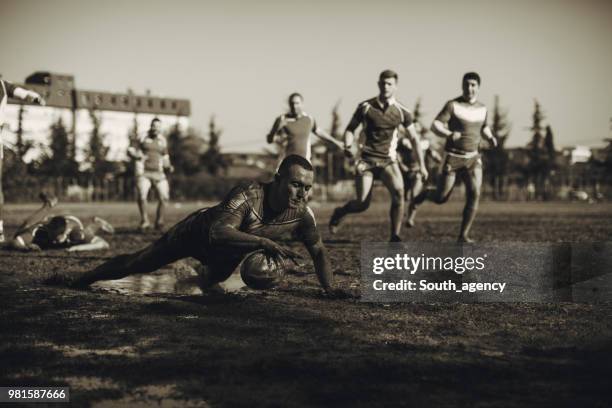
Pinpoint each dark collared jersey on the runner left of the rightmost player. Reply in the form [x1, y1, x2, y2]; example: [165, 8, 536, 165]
[346, 98, 412, 159]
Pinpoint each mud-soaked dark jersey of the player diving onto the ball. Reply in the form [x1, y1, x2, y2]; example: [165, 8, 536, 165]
[168, 182, 320, 252]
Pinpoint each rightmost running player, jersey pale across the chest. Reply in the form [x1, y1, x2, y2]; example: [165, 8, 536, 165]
[409, 72, 497, 242]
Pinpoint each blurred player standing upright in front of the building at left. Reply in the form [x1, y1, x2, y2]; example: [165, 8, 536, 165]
[128, 118, 174, 231]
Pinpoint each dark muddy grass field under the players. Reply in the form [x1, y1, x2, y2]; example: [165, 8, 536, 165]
[0, 203, 612, 407]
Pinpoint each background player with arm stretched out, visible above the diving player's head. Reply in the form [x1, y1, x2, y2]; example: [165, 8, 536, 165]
[266, 92, 343, 160]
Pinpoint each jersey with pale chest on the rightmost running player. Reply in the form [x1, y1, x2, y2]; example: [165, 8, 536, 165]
[436, 97, 487, 154]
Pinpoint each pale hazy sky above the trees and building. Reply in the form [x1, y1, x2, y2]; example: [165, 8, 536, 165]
[0, 0, 612, 151]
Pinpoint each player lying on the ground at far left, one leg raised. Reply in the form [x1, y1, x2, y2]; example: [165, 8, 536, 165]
[5, 194, 115, 252]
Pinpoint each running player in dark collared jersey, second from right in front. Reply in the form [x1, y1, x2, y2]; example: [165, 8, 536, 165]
[329, 70, 427, 242]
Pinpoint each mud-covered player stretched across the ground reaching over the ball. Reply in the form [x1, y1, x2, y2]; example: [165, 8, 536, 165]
[64, 155, 333, 292]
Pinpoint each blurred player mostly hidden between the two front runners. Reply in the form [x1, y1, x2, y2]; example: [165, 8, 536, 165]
[397, 128, 442, 227]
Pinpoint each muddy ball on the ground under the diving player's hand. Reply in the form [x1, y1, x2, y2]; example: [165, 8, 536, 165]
[240, 251, 285, 290]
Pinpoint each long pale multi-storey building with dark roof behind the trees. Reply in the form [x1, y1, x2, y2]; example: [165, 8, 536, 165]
[3, 72, 191, 162]
